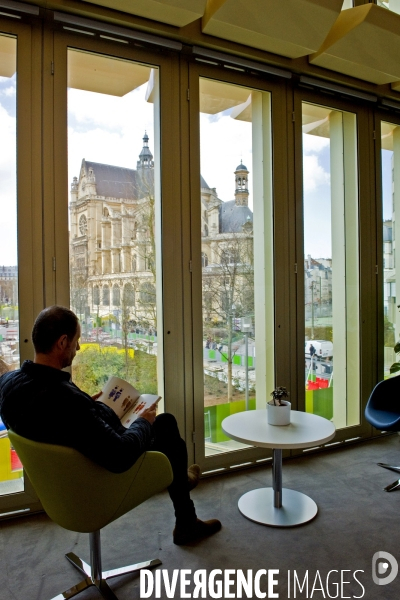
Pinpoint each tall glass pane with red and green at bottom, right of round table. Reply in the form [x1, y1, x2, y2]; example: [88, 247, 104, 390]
[303, 102, 360, 428]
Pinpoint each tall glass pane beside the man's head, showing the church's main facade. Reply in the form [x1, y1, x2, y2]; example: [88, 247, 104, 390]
[68, 49, 162, 404]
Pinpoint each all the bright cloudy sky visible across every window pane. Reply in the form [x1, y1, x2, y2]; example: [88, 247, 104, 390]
[0, 62, 392, 265]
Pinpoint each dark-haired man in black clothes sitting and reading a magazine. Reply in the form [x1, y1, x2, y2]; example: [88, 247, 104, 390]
[0, 306, 221, 545]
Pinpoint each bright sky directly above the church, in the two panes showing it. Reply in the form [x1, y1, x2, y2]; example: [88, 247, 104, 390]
[68, 84, 252, 206]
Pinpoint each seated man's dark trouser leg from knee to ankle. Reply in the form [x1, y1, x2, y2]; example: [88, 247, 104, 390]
[151, 413, 196, 524]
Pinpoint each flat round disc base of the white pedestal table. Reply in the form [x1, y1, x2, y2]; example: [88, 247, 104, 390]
[238, 488, 318, 527]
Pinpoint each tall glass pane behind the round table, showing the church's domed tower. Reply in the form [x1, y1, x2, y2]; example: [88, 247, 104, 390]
[200, 78, 274, 456]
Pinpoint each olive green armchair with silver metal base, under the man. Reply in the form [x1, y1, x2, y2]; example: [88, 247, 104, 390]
[9, 431, 172, 600]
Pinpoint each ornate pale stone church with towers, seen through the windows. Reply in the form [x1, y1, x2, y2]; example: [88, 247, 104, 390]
[69, 133, 253, 327]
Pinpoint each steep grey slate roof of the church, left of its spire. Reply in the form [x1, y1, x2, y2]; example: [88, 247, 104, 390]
[85, 161, 141, 199]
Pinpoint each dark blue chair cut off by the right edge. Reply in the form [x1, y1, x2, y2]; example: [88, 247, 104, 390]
[365, 376, 400, 492]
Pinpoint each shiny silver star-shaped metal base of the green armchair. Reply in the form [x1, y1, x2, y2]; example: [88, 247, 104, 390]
[52, 552, 161, 600]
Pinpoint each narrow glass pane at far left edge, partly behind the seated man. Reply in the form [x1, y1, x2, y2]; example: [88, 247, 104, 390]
[0, 34, 23, 494]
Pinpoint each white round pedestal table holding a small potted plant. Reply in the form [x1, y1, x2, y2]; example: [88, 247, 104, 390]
[222, 410, 336, 527]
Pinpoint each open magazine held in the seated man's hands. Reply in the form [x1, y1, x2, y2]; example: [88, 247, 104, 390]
[97, 377, 161, 428]
